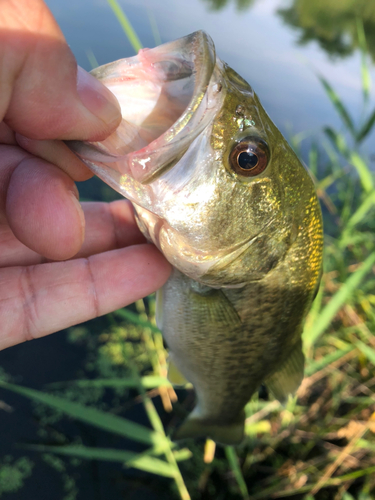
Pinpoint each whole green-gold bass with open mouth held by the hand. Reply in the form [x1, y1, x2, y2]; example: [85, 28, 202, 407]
[70, 31, 323, 444]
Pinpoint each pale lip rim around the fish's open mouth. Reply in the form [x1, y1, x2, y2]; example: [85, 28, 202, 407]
[67, 30, 216, 184]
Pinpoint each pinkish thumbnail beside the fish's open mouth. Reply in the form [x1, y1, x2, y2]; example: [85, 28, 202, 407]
[77, 66, 121, 125]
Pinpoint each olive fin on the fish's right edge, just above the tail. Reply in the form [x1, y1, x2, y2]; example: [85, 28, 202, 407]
[266, 341, 305, 403]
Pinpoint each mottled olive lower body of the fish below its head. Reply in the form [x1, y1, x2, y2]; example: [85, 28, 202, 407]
[158, 270, 306, 443]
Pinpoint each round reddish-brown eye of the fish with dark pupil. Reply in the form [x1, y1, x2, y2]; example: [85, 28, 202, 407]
[229, 137, 270, 177]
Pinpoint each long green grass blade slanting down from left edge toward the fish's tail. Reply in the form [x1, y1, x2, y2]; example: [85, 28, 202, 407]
[0, 381, 166, 446]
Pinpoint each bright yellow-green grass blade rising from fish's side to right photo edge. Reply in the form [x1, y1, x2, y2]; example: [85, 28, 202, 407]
[303, 252, 375, 349]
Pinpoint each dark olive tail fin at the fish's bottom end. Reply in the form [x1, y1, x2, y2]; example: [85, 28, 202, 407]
[172, 413, 245, 445]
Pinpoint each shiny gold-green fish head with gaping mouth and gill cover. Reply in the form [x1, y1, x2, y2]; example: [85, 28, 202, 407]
[69, 31, 321, 288]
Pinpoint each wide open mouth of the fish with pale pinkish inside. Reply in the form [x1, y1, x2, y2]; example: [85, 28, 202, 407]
[67, 31, 221, 188]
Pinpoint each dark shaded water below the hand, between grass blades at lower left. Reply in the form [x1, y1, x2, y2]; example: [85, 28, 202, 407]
[0, 315, 170, 500]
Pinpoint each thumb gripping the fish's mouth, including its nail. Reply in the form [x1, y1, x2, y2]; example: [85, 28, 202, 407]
[0, 0, 121, 140]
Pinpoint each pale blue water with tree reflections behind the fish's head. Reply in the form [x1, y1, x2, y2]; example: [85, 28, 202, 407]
[47, 0, 375, 152]
